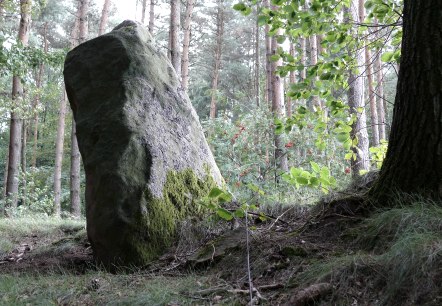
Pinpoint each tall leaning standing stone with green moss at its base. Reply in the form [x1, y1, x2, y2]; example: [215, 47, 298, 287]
[64, 21, 222, 267]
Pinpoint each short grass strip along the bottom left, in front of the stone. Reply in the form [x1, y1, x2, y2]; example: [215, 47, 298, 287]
[0, 272, 205, 306]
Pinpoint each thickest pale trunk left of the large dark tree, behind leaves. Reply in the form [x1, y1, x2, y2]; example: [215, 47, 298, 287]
[347, 0, 370, 176]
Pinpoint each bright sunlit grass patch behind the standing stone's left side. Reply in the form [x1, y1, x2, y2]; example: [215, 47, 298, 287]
[0, 216, 85, 257]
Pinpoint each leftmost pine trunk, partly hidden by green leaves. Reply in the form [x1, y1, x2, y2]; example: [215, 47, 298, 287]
[6, 0, 32, 213]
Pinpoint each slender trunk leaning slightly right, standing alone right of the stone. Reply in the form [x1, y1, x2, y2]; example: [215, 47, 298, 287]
[210, 0, 224, 119]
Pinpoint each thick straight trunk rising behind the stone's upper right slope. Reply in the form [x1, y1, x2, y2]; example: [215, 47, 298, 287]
[169, 0, 181, 74]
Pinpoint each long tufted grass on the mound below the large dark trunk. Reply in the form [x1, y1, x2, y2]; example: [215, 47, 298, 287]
[291, 198, 442, 305]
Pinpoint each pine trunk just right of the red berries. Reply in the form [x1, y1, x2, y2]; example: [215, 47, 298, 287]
[272, 25, 288, 171]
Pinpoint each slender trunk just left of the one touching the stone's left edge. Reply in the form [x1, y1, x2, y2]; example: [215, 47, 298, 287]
[54, 91, 67, 216]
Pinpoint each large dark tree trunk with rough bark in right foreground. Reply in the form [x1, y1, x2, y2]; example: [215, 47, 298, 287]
[371, 0, 442, 203]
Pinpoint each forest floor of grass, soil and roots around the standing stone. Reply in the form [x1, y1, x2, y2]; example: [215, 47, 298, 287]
[0, 192, 442, 305]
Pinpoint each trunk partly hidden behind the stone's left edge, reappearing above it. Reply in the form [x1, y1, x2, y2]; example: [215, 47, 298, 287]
[69, 0, 89, 217]
